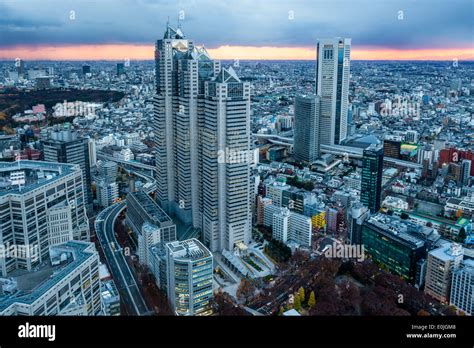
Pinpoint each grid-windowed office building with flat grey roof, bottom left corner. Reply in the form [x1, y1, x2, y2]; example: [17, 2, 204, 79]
[0, 241, 102, 316]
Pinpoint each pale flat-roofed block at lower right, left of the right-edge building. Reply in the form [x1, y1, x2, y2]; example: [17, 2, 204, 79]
[425, 243, 463, 302]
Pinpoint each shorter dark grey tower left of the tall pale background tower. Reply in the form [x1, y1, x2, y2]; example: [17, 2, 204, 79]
[293, 95, 320, 163]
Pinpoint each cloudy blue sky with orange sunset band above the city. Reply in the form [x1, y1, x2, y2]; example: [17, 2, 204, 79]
[0, 0, 474, 60]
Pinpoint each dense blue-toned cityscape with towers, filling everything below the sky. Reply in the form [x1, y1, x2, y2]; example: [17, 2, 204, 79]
[0, 5, 474, 332]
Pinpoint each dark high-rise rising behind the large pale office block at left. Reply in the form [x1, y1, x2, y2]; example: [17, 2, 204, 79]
[42, 129, 92, 208]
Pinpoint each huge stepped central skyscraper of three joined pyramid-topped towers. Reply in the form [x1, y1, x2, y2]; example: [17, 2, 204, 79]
[153, 25, 253, 252]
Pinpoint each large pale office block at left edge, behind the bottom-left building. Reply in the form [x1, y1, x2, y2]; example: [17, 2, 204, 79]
[0, 161, 89, 276]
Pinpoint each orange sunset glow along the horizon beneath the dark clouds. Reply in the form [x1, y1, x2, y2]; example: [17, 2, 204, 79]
[0, 44, 474, 60]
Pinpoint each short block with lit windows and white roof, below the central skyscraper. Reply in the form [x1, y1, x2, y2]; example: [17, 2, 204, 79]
[166, 239, 214, 315]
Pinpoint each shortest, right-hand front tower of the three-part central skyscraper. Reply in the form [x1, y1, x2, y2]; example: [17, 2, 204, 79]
[201, 68, 252, 252]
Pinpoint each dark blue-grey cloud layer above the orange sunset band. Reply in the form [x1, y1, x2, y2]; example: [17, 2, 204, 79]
[0, 0, 474, 48]
